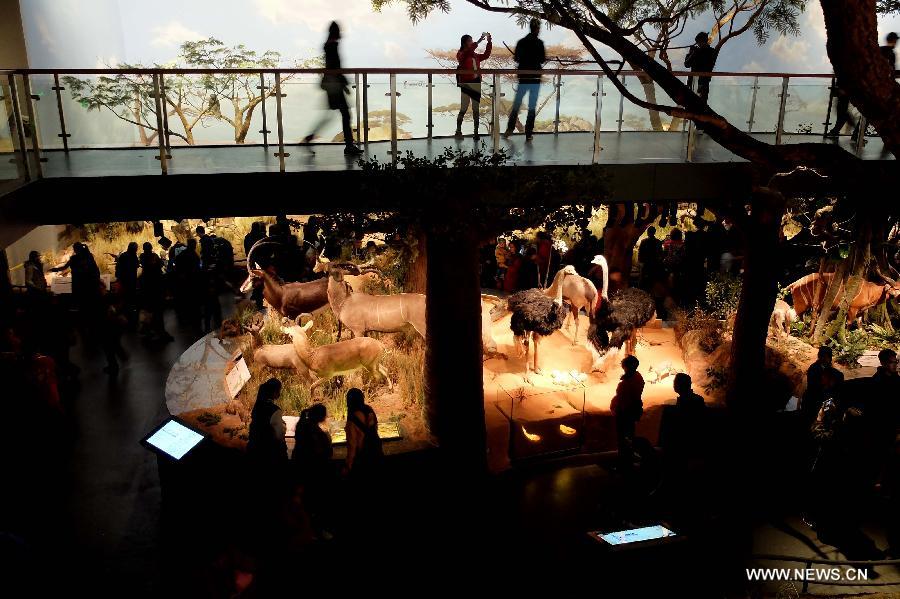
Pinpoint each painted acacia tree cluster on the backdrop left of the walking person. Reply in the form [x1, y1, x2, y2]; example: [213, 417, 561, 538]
[64, 38, 321, 145]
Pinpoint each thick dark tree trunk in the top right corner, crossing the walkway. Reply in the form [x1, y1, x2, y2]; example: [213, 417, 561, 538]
[822, 0, 900, 158]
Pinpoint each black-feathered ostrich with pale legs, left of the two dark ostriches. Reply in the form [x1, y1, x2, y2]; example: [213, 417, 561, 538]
[507, 269, 574, 382]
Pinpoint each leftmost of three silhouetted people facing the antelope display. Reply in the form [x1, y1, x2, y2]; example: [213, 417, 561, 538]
[247, 378, 287, 473]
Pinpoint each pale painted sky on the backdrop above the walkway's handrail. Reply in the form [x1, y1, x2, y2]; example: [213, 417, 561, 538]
[21, 0, 900, 72]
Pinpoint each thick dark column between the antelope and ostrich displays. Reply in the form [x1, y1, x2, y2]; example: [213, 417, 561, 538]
[425, 220, 486, 478]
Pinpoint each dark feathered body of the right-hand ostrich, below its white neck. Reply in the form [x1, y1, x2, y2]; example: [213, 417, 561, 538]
[588, 287, 656, 371]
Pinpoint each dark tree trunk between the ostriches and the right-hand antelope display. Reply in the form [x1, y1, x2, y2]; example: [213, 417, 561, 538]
[726, 191, 785, 412]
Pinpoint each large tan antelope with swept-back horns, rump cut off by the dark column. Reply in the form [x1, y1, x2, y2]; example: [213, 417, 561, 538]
[315, 251, 425, 339]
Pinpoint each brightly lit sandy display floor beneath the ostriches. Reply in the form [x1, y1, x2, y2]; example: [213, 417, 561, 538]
[483, 315, 716, 469]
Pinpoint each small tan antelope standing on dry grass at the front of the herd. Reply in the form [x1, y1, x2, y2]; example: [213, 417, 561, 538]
[281, 314, 394, 394]
